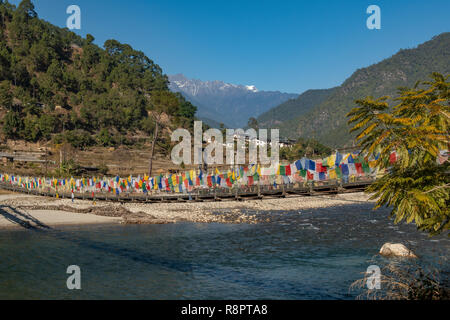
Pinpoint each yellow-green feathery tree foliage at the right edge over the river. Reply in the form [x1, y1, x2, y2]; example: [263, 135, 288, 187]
[347, 73, 450, 235]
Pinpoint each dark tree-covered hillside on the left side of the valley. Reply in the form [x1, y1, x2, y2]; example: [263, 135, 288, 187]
[0, 0, 196, 148]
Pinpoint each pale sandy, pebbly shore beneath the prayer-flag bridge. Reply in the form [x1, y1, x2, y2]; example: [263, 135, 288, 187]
[0, 193, 369, 228]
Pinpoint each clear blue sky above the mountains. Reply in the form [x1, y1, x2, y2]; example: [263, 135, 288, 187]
[10, 0, 450, 93]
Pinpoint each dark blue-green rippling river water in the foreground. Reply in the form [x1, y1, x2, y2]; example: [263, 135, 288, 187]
[0, 203, 450, 299]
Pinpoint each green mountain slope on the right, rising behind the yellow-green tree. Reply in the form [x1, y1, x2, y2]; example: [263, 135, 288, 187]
[257, 32, 450, 147]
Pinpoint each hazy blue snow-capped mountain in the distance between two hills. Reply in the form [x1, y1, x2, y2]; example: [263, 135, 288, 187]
[169, 74, 298, 128]
